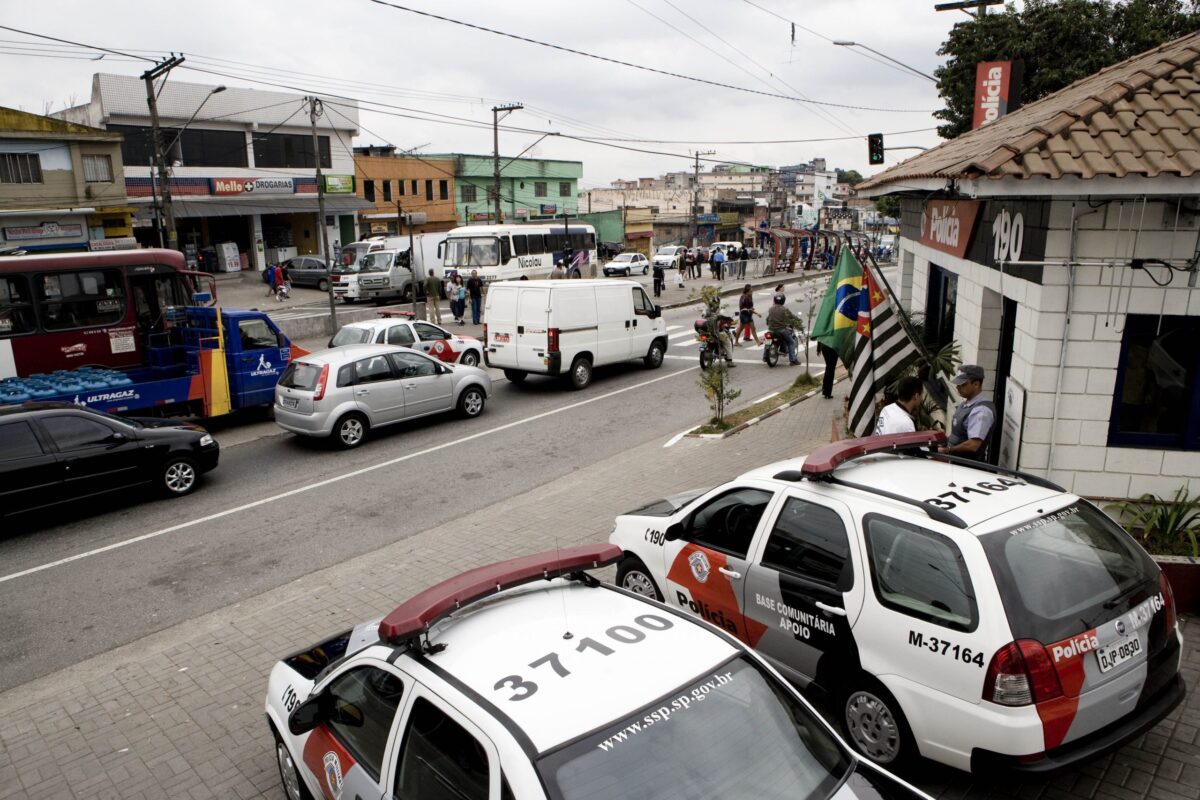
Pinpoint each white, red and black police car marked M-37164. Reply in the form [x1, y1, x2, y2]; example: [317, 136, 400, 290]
[610, 433, 1184, 772]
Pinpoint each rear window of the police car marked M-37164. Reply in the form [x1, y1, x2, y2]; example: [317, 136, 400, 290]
[982, 500, 1158, 642]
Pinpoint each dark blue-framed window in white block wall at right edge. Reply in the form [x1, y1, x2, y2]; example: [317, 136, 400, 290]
[1109, 314, 1200, 450]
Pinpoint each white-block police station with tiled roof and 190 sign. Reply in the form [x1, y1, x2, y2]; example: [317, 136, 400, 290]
[857, 34, 1200, 498]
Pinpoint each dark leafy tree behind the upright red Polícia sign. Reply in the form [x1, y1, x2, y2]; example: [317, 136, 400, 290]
[934, 0, 1200, 139]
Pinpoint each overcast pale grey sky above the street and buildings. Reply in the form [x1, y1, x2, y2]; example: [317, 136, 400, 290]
[0, 0, 966, 188]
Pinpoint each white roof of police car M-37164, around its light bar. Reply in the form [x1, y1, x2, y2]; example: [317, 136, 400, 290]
[745, 453, 1074, 533]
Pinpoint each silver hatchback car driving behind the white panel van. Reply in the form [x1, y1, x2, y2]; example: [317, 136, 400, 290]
[275, 344, 492, 447]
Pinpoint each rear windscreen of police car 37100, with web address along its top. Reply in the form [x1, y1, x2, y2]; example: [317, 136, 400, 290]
[539, 656, 852, 800]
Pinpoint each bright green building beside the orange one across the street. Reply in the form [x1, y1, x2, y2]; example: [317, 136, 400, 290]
[434, 154, 583, 224]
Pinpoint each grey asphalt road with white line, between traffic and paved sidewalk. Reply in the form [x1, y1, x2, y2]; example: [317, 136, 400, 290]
[0, 295, 817, 691]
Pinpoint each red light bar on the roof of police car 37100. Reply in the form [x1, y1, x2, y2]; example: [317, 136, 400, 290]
[379, 545, 622, 644]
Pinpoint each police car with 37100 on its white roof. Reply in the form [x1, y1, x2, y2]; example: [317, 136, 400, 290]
[266, 545, 928, 800]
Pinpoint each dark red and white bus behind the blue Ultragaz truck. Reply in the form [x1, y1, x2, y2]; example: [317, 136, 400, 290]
[0, 249, 211, 378]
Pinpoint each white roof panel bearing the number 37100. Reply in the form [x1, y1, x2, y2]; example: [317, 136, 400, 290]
[427, 581, 739, 752]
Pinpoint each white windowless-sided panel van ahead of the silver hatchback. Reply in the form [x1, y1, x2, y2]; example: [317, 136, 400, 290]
[484, 281, 667, 389]
